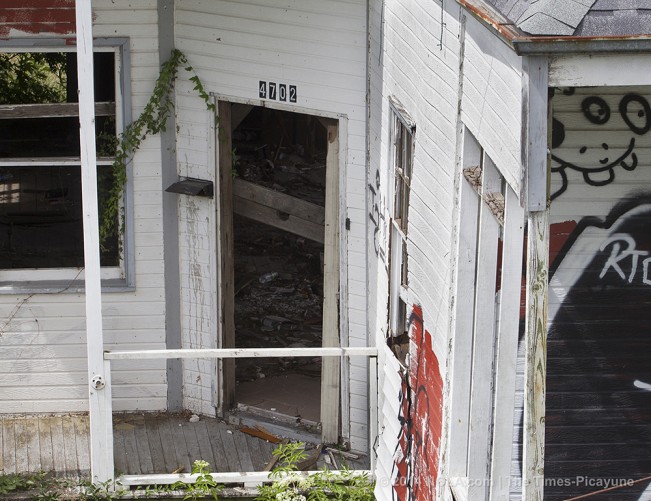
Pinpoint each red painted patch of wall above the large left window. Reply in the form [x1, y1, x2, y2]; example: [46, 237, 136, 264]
[0, 0, 75, 38]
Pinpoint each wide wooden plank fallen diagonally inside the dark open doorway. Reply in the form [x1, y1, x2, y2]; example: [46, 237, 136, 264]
[233, 179, 325, 226]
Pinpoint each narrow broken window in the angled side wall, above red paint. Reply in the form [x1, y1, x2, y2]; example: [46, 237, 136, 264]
[389, 95, 415, 360]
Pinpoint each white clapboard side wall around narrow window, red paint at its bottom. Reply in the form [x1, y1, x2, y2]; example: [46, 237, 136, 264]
[367, 1, 460, 499]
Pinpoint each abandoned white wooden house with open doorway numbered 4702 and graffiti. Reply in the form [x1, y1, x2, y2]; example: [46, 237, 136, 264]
[0, 0, 651, 501]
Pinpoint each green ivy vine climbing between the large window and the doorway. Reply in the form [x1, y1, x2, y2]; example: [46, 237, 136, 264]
[99, 49, 217, 247]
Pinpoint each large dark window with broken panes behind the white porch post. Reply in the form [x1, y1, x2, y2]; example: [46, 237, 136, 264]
[0, 47, 122, 280]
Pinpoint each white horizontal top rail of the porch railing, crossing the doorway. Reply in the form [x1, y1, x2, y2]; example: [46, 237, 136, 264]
[104, 347, 377, 360]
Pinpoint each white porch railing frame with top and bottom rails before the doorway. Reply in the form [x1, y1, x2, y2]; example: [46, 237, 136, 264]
[99, 347, 377, 487]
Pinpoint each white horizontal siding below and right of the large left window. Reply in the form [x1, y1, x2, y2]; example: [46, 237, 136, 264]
[0, 0, 166, 413]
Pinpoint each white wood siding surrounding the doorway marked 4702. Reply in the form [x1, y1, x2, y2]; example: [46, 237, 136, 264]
[176, 0, 368, 449]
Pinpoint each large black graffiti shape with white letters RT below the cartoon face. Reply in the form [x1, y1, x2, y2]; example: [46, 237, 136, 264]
[545, 196, 651, 500]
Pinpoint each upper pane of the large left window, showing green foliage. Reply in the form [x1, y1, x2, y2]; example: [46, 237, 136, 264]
[0, 52, 116, 158]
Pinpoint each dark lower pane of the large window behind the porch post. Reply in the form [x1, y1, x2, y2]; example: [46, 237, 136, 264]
[0, 166, 119, 269]
